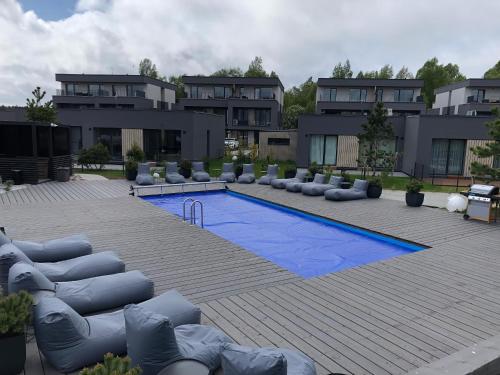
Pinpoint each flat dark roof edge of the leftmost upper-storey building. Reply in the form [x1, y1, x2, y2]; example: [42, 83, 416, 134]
[56, 73, 177, 90]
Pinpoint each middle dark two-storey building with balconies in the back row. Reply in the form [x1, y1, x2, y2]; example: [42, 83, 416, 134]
[178, 76, 284, 145]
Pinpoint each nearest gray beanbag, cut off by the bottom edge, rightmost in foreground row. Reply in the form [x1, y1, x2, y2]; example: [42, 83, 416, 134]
[221, 344, 316, 375]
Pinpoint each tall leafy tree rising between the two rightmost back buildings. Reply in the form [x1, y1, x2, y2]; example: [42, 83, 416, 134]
[416, 57, 465, 108]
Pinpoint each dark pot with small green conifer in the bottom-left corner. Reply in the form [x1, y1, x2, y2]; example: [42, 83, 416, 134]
[0, 291, 33, 375]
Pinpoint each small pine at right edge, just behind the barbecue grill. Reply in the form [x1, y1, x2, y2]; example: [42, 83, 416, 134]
[471, 108, 500, 181]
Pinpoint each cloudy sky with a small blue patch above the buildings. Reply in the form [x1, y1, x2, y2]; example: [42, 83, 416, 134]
[0, 0, 500, 105]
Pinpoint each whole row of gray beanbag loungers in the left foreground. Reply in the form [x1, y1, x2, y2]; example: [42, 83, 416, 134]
[0, 232, 316, 375]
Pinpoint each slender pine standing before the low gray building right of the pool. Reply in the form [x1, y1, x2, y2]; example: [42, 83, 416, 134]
[358, 102, 394, 176]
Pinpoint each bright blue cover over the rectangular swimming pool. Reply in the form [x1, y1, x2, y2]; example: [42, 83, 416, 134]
[144, 191, 423, 278]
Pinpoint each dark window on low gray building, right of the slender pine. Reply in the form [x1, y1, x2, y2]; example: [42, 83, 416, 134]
[431, 139, 465, 175]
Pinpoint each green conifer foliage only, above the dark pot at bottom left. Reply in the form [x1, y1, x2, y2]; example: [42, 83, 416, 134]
[0, 291, 33, 337]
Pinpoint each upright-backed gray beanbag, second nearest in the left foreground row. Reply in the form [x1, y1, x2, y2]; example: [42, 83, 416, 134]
[123, 305, 232, 375]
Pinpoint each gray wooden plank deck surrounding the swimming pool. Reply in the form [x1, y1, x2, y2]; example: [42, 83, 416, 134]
[0, 181, 500, 375]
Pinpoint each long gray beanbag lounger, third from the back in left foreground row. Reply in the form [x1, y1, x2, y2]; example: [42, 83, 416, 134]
[9, 262, 154, 314]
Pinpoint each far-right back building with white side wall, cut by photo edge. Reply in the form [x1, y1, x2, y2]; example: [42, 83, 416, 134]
[432, 79, 500, 116]
